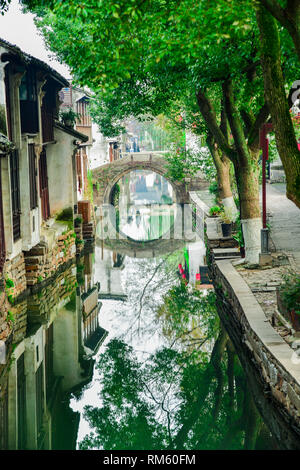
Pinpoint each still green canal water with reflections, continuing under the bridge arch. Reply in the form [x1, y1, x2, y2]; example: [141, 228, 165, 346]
[0, 171, 275, 450]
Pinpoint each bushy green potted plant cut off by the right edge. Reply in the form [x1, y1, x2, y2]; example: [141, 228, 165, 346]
[277, 272, 300, 331]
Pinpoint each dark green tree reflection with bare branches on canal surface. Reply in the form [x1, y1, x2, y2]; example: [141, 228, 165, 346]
[80, 259, 273, 450]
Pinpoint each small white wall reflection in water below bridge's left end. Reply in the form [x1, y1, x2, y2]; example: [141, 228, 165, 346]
[95, 247, 126, 300]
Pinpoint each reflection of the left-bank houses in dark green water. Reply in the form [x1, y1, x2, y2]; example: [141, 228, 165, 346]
[0, 258, 106, 449]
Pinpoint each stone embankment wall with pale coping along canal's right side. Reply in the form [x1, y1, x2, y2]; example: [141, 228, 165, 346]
[207, 219, 300, 449]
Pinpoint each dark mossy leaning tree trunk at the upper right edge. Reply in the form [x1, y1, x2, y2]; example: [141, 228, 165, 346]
[257, 5, 300, 207]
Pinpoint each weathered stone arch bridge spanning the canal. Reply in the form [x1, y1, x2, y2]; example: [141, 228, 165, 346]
[92, 152, 207, 206]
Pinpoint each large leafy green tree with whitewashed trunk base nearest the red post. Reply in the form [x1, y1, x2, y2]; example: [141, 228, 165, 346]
[20, 0, 294, 263]
